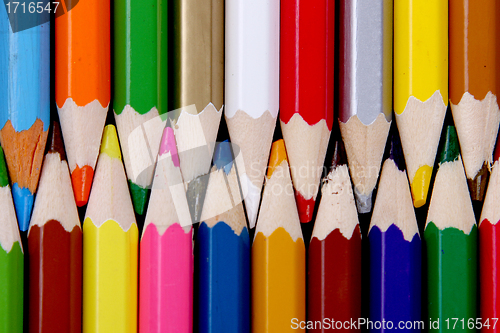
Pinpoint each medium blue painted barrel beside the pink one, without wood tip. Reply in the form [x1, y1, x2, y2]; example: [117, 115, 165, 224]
[195, 221, 250, 333]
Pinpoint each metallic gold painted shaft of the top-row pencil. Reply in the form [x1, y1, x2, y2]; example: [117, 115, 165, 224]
[170, 0, 224, 113]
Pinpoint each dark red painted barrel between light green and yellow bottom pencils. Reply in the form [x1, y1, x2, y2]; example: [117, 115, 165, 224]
[28, 220, 82, 333]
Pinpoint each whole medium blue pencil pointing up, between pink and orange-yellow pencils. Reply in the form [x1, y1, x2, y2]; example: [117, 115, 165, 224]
[195, 141, 250, 333]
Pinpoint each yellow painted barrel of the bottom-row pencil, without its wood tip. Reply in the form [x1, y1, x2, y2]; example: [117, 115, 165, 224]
[83, 218, 138, 333]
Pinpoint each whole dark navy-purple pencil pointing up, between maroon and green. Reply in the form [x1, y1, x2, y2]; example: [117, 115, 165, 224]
[368, 128, 422, 331]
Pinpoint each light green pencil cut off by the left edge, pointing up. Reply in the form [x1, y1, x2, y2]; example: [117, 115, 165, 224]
[0, 147, 24, 333]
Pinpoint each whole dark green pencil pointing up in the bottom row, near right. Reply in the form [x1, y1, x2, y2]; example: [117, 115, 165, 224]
[424, 121, 477, 326]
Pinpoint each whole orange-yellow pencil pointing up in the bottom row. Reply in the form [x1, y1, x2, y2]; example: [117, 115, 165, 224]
[252, 140, 306, 333]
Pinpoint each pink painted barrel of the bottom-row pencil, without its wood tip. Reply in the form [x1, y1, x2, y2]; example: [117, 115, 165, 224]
[139, 224, 193, 333]
